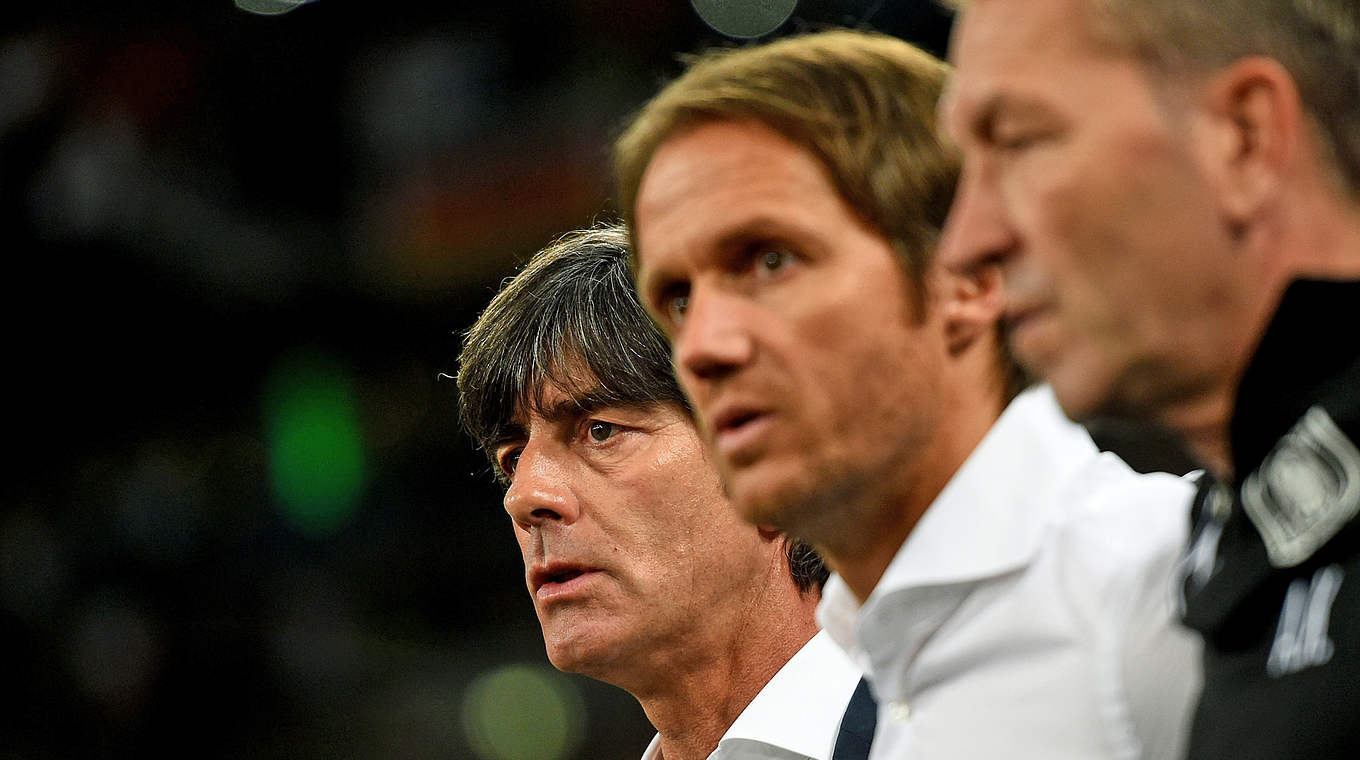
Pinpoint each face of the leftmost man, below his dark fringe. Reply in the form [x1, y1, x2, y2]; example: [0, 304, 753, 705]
[495, 389, 792, 677]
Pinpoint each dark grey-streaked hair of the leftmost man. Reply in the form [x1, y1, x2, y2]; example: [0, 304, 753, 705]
[458, 224, 828, 591]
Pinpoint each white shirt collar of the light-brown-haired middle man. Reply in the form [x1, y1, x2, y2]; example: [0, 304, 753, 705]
[817, 386, 1096, 663]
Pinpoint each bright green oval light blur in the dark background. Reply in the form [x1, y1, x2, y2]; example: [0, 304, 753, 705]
[264, 352, 366, 537]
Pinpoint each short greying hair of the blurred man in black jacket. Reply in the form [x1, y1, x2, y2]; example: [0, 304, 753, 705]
[942, 0, 1360, 200]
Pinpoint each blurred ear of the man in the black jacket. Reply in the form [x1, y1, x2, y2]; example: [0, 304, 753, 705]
[1198, 56, 1306, 224]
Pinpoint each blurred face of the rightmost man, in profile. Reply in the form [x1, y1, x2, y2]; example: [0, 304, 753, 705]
[940, 0, 1238, 417]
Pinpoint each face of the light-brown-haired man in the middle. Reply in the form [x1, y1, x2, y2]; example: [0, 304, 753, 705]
[636, 121, 947, 542]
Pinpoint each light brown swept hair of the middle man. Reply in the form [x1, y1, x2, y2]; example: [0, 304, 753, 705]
[613, 30, 959, 302]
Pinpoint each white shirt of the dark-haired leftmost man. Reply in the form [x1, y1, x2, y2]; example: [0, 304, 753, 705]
[642, 631, 862, 760]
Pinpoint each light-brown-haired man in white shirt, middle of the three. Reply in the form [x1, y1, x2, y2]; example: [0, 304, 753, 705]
[615, 31, 1200, 760]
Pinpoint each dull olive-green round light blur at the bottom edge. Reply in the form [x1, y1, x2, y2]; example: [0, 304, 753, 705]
[462, 665, 585, 760]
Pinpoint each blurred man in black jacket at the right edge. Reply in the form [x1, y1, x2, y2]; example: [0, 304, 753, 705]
[941, 0, 1360, 760]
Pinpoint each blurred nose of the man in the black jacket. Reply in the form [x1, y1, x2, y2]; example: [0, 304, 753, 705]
[938, 163, 1016, 275]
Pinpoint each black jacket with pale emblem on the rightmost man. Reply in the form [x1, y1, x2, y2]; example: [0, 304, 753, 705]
[1183, 280, 1360, 760]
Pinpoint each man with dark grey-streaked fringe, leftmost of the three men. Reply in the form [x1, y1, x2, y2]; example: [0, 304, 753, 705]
[458, 226, 874, 760]
